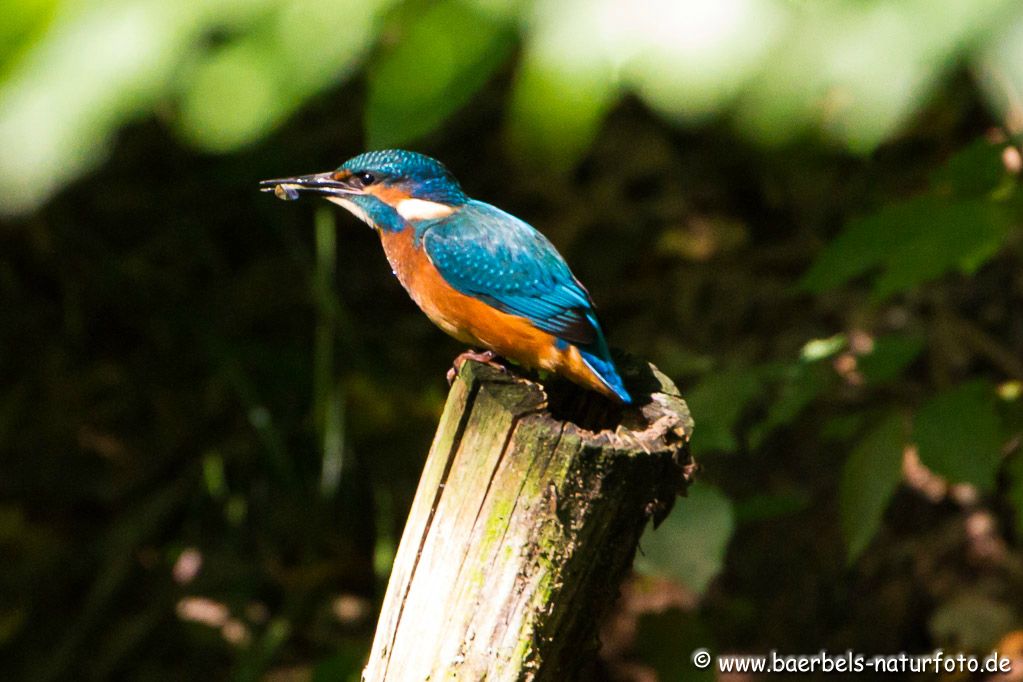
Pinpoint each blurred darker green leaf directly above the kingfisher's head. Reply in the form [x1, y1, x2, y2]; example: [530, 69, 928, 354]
[365, 1, 513, 148]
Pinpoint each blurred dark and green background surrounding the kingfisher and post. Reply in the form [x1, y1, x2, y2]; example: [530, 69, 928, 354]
[6, 0, 1023, 682]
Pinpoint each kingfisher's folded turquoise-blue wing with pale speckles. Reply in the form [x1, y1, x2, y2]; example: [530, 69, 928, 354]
[421, 201, 602, 345]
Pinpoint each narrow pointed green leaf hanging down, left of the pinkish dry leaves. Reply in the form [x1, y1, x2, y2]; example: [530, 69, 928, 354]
[839, 414, 905, 562]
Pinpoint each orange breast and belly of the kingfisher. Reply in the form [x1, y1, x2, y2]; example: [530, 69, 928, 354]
[381, 228, 613, 396]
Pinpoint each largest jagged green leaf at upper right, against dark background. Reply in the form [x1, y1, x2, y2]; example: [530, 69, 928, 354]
[800, 195, 1011, 301]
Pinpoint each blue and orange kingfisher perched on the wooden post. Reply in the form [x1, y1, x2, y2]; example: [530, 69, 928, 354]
[260, 149, 632, 405]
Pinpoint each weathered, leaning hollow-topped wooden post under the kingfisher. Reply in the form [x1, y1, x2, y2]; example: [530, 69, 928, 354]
[363, 359, 694, 682]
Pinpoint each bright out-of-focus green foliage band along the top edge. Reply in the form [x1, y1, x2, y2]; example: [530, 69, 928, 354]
[6, 0, 1023, 214]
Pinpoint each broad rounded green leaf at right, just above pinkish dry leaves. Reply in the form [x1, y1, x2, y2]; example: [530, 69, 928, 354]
[913, 379, 1002, 490]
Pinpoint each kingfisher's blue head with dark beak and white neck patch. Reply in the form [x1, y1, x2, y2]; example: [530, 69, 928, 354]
[260, 149, 469, 230]
